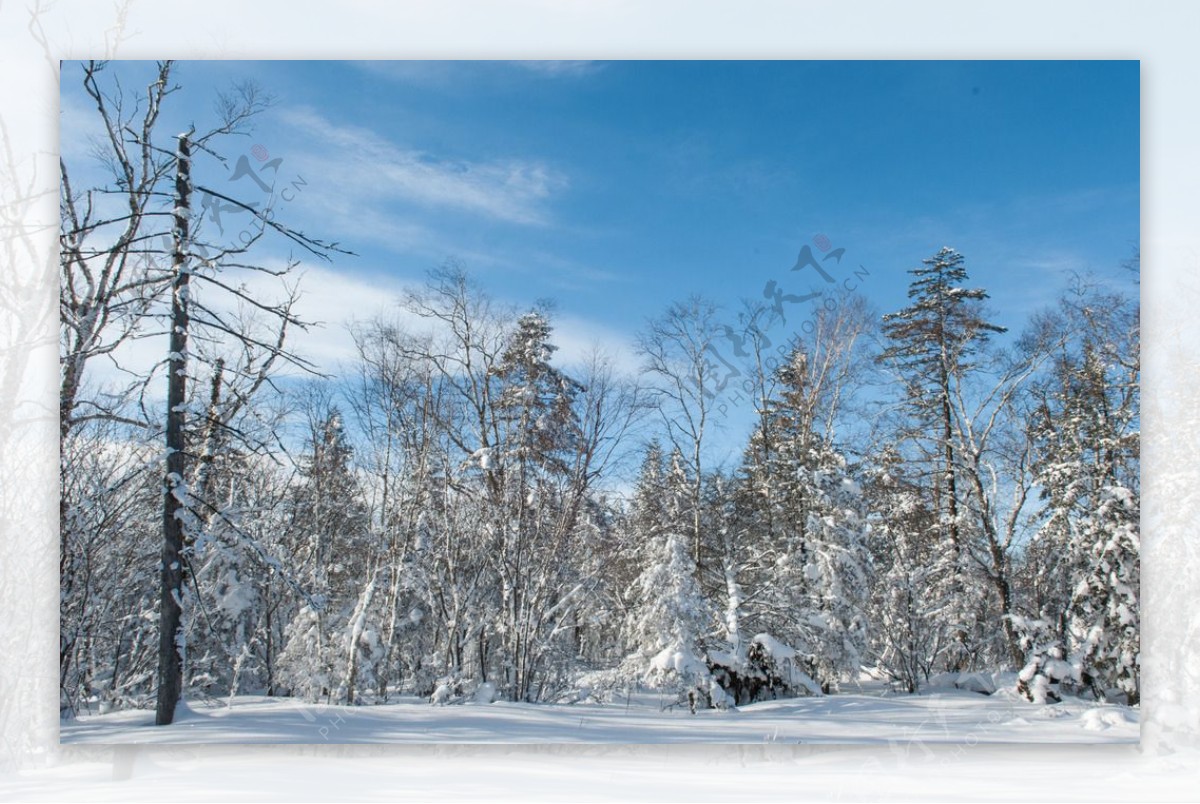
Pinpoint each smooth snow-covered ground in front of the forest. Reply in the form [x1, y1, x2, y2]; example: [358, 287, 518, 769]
[60, 689, 1139, 746]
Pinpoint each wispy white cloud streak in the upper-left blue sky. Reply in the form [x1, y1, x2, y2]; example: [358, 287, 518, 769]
[281, 108, 568, 226]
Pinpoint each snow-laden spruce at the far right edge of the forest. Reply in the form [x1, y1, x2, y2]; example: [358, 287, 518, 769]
[1030, 285, 1140, 703]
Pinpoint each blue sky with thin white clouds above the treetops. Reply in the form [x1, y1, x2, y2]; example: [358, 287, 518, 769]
[62, 61, 1140, 463]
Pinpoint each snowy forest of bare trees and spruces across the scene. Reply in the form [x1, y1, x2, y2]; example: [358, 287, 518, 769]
[59, 62, 1140, 725]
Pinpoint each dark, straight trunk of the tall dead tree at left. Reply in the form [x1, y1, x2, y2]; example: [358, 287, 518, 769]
[155, 134, 192, 726]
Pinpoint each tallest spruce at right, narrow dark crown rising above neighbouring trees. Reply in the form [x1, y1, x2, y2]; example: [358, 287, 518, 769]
[878, 247, 1006, 670]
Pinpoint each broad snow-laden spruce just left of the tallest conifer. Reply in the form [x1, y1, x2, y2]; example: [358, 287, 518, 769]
[743, 348, 870, 691]
